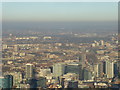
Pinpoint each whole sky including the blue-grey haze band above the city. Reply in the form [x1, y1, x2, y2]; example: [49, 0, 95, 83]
[3, 2, 118, 32]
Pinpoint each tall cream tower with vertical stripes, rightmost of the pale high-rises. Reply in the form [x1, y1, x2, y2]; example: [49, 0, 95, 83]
[105, 61, 114, 78]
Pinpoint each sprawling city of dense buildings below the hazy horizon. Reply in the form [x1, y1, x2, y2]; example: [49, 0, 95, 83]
[0, 32, 120, 88]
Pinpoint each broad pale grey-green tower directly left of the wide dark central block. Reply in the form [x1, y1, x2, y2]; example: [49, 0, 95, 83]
[53, 63, 65, 77]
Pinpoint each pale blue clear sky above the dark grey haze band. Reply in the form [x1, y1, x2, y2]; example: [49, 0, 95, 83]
[2, 2, 118, 22]
